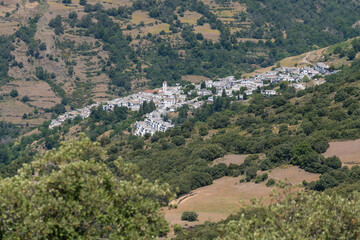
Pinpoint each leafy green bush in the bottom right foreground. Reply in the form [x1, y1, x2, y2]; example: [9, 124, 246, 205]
[220, 190, 360, 240]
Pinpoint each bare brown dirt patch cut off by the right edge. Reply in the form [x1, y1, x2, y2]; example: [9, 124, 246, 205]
[324, 139, 360, 167]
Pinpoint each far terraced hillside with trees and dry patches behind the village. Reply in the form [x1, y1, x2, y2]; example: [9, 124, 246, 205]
[0, 0, 360, 126]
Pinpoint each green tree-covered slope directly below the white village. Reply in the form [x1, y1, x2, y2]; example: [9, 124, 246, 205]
[1, 58, 360, 197]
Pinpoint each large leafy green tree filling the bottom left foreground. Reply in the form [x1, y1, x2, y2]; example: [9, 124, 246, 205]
[0, 138, 172, 239]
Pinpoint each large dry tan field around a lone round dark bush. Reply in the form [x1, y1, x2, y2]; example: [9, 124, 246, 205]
[163, 166, 319, 226]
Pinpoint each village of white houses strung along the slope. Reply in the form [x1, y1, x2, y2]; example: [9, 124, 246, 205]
[49, 63, 334, 136]
